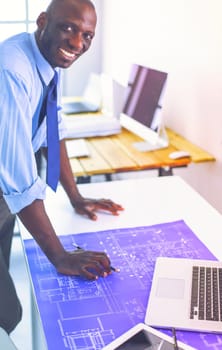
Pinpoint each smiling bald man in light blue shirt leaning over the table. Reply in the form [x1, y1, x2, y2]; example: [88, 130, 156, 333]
[0, 0, 123, 333]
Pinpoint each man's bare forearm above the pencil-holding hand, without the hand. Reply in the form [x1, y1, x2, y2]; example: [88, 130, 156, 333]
[18, 200, 65, 266]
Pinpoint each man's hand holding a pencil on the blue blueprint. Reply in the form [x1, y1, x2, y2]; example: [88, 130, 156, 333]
[56, 249, 111, 280]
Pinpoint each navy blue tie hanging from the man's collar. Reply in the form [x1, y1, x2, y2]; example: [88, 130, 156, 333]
[46, 72, 60, 191]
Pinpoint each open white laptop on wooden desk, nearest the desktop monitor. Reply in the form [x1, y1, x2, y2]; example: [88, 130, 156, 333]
[63, 74, 125, 138]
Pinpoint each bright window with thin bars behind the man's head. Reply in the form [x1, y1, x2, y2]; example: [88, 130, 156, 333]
[0, 0, 50, 40]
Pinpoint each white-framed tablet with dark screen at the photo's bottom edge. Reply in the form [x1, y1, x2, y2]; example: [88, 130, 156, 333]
[103, 323, 195, 350]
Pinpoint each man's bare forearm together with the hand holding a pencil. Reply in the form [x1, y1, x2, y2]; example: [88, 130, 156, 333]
[18, 200, 111, 279]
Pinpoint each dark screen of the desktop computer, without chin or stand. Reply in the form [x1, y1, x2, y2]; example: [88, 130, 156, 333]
[123, 64, 168, 129]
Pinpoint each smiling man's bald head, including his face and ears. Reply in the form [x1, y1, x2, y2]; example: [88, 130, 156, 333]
[36, 0, 96, 68]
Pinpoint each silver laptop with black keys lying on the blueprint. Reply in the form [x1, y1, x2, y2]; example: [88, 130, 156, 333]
[145, 257, 222, 333]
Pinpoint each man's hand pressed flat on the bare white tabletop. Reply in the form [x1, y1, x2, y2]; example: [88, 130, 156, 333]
[72, 197, 124, 220]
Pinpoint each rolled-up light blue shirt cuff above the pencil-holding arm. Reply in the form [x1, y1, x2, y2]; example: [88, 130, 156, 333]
[3, 177, 47, 214]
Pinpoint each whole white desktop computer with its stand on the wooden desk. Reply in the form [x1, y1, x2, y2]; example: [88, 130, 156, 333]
[121, 64, 169, 151]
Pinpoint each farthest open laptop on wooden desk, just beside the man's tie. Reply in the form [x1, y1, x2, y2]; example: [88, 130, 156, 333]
[62, 73, 102, 114]
